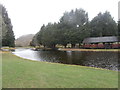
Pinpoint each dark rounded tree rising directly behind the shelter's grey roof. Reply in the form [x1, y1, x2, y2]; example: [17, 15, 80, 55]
[91, 11, 118, 37]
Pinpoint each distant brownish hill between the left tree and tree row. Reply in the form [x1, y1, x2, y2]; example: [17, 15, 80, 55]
[15, 34, 34, 47]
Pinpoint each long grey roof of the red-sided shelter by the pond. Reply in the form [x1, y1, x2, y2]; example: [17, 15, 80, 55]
[83, 36, 118, 43]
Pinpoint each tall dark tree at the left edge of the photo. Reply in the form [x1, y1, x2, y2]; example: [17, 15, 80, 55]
[0, 4, 15, 47]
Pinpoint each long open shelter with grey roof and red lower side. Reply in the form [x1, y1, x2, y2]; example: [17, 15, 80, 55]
[83, 36, 120, 48]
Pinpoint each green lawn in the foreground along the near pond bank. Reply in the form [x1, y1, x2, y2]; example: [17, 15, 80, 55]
[2, 53, 118, 88]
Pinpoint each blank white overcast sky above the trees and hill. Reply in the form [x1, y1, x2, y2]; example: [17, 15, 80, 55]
[0, 0, 119, 38]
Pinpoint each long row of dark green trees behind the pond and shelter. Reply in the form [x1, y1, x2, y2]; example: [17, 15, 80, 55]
[30, 9, 118, 48]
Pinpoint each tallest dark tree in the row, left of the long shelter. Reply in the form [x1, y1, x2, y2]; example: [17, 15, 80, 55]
[60, 9, 89, 48]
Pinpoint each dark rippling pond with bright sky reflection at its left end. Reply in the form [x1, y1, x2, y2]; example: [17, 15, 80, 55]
[13, 49, 120, 71]
